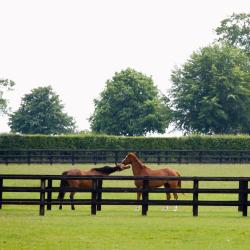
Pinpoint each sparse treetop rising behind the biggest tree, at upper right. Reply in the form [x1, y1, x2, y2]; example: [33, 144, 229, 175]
[215, 13, 250, 53]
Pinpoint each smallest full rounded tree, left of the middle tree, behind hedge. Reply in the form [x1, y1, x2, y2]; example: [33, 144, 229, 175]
[9, 86, 75, 134]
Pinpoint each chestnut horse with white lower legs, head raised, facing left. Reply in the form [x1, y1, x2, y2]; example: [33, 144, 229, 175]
[122, 153, 181, 211]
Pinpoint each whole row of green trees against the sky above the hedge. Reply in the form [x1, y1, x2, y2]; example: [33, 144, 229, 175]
[0, 13, 250, 138]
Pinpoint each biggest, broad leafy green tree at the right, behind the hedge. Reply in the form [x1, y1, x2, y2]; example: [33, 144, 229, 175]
[170, 45, 250, 134]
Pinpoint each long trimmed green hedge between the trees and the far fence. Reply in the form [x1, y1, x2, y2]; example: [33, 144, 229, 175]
[0, 134, 250, 150]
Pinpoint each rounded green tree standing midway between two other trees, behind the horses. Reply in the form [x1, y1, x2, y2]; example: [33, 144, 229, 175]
[90, 68, 170, 136]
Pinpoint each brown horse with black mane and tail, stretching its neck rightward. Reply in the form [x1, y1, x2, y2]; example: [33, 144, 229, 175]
[58, 164, 130, 210]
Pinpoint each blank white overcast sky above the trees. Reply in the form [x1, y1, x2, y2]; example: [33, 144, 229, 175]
[0, 0, 250, 135]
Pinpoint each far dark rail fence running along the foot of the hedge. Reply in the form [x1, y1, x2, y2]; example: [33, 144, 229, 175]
[0, 150, 250, 164]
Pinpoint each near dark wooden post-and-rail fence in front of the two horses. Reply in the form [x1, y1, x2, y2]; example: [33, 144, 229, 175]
[0, 175, 250, 216]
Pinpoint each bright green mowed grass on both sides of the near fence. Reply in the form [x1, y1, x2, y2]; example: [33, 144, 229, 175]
[0, 164, 250, 250]
